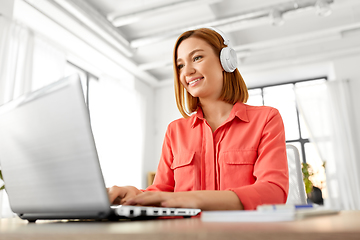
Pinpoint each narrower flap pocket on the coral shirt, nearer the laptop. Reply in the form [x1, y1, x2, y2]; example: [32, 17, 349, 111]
[170, 151, 195, 192]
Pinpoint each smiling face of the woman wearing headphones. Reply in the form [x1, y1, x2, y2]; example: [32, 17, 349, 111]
[176, 37, 223, 102]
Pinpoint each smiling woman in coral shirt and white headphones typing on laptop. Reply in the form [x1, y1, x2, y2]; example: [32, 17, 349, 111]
[109, 28, 288, 210]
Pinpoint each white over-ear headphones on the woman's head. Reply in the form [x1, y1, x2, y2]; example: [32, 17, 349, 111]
[207, 27, 237, 72]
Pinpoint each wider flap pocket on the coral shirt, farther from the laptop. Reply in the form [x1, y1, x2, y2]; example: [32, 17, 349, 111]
[219, 149, 257, 190]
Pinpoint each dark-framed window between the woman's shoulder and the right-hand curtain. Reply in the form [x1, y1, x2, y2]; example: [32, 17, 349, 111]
[247, 78, 327, 198]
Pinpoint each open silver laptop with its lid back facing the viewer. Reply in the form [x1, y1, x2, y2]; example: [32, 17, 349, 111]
[0, 75, 200, 221]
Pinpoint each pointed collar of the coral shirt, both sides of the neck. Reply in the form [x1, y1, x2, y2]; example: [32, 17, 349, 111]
[191, 102, 249, 128]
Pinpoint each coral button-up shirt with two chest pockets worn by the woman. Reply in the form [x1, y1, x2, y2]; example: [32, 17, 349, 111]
[146, 103, 289, 210]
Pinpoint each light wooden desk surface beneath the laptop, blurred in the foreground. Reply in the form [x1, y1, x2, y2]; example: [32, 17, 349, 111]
[0, 211, 360, 240]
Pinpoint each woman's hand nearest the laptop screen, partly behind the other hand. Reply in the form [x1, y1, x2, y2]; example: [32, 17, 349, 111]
[107, 186, 142, 204]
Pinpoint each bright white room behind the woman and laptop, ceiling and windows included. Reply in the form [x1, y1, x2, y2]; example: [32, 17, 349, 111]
[0, 0, 360, 214]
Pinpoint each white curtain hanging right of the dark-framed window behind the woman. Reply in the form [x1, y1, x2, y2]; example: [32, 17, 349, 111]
[295, 80, 360, 210]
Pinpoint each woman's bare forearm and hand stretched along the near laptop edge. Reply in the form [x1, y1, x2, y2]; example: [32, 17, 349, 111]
[125, 191, 243, 210]
